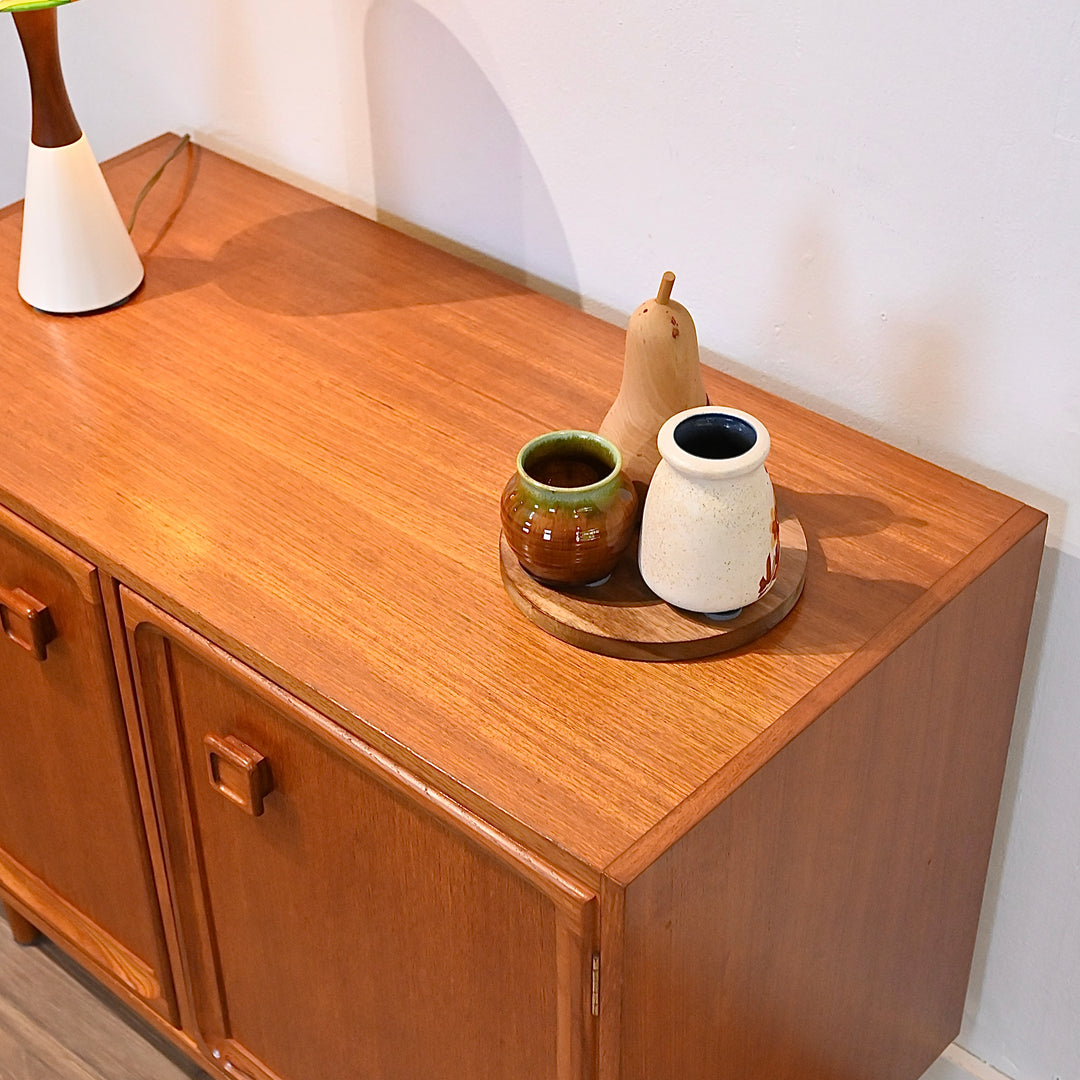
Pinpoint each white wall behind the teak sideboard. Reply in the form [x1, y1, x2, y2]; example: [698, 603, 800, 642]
[0, 0, 1080, 1080]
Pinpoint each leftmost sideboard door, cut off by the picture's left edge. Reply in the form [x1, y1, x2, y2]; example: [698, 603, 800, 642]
[0, 501, 173, 1018]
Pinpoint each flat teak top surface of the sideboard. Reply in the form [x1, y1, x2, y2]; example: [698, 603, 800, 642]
[0, 137, 1031, 869]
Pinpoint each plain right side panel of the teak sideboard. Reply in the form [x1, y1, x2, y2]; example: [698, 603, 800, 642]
[621, 520, 1043, 1080]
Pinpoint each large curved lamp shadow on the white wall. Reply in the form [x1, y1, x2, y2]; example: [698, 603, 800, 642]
[364, 0, 580, 306]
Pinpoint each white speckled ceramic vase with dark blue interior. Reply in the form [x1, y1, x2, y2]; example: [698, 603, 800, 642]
[638, 405, 780, 617]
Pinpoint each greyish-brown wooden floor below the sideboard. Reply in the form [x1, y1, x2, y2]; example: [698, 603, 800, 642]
[0, 916, 210, 1080]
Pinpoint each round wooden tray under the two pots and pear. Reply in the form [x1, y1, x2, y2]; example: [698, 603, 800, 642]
[499, 510, 807, 660]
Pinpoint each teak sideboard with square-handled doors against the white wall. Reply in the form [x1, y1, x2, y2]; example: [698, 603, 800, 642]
[0, 136, 1045, 1080]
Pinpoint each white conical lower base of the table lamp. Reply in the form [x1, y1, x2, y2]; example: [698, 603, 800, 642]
[18, 135, 143, 314]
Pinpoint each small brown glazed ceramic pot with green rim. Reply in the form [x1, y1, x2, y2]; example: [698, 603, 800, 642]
[501, 431, 637, 586]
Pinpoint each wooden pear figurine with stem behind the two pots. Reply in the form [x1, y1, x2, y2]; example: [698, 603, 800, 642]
[599, 270, 708, 494]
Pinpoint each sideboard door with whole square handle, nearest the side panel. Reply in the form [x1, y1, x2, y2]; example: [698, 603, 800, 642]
[123, 593, 596, 1080]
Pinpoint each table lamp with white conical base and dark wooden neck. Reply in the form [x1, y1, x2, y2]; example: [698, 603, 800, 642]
[0, 0, 143, 314]
